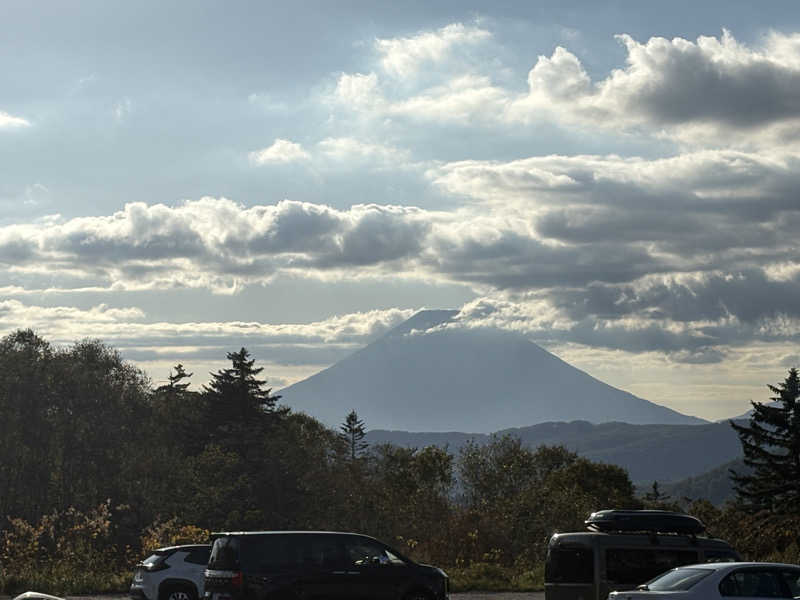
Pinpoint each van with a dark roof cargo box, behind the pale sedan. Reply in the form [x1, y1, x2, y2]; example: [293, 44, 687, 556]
[545, 511, 741, 600]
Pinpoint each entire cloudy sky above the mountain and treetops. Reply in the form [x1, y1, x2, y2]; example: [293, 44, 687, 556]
[0, 0, 800, 426]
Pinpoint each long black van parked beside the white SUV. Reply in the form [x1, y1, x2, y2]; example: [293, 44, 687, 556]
[204, 531, 448, 600]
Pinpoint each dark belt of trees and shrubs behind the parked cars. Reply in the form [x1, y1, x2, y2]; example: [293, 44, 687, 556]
[0, 330, 796, 593]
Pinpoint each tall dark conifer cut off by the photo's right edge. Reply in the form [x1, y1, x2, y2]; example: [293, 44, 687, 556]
[730, 368, 800, 516]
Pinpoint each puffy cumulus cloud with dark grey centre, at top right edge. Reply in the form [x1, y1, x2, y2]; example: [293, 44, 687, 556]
[507, 31, 800, 145]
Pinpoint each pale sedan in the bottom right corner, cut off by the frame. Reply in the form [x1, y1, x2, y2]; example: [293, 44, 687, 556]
[608, 562, 800, 600]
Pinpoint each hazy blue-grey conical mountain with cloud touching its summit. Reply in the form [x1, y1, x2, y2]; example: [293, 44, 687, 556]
[280, 310, 705, 433]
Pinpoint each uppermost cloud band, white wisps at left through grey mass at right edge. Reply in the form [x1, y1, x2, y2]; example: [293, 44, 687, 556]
[334, 24, 800, 147]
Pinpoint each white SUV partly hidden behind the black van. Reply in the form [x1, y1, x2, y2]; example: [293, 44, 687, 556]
[130, 544, 211, 600]
